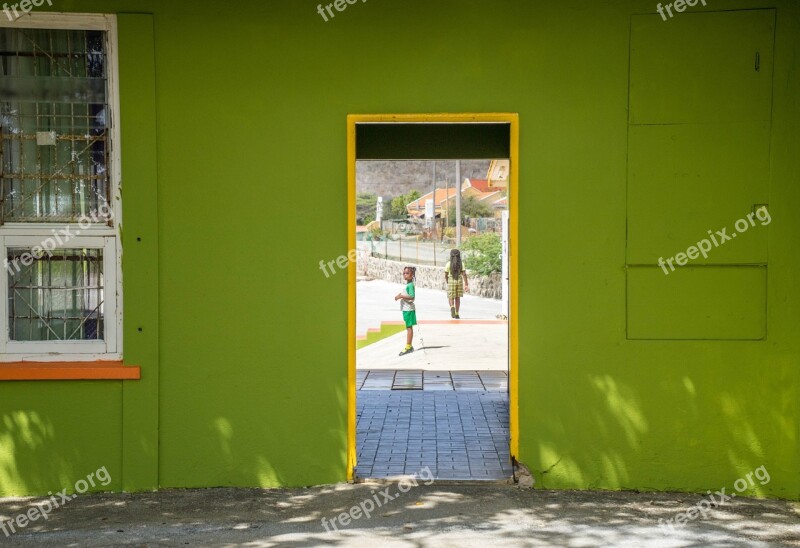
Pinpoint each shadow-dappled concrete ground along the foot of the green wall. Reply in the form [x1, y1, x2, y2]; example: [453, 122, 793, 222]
[0, 484, 800, 548]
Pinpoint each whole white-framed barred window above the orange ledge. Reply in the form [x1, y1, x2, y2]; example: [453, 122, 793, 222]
[0, 14, 122, 362]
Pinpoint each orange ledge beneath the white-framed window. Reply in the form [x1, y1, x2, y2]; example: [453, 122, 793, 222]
[0, 361, 142, 381]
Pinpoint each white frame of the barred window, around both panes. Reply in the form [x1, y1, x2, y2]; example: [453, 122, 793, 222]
[0, 13, 123, 362]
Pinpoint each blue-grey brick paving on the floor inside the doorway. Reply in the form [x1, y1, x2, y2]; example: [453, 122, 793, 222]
[356, 394, 512, 480]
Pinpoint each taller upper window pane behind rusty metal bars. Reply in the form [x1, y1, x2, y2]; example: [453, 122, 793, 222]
[0, 28, 110, 223]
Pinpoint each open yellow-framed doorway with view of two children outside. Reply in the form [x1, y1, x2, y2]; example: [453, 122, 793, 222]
[348, 114, 518, 480]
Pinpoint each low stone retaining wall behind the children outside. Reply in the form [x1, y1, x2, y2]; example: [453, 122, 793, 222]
[356, 251, 503, 299]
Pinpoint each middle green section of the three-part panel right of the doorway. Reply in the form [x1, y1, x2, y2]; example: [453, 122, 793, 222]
[627, 122, 770, 264]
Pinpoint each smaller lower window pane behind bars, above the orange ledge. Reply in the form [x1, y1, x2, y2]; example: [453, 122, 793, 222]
[6, 248, 104, 341]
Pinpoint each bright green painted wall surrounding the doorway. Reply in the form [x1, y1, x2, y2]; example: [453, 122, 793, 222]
[0, 0, 800, 499]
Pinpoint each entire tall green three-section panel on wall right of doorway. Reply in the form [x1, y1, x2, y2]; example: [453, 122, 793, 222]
[626, 9, 775, 340]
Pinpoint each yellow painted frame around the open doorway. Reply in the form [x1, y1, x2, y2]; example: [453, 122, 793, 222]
[347, 113, 519, 481]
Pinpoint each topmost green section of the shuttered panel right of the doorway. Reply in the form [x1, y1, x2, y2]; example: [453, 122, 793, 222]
[630, 9, 775, 124]
